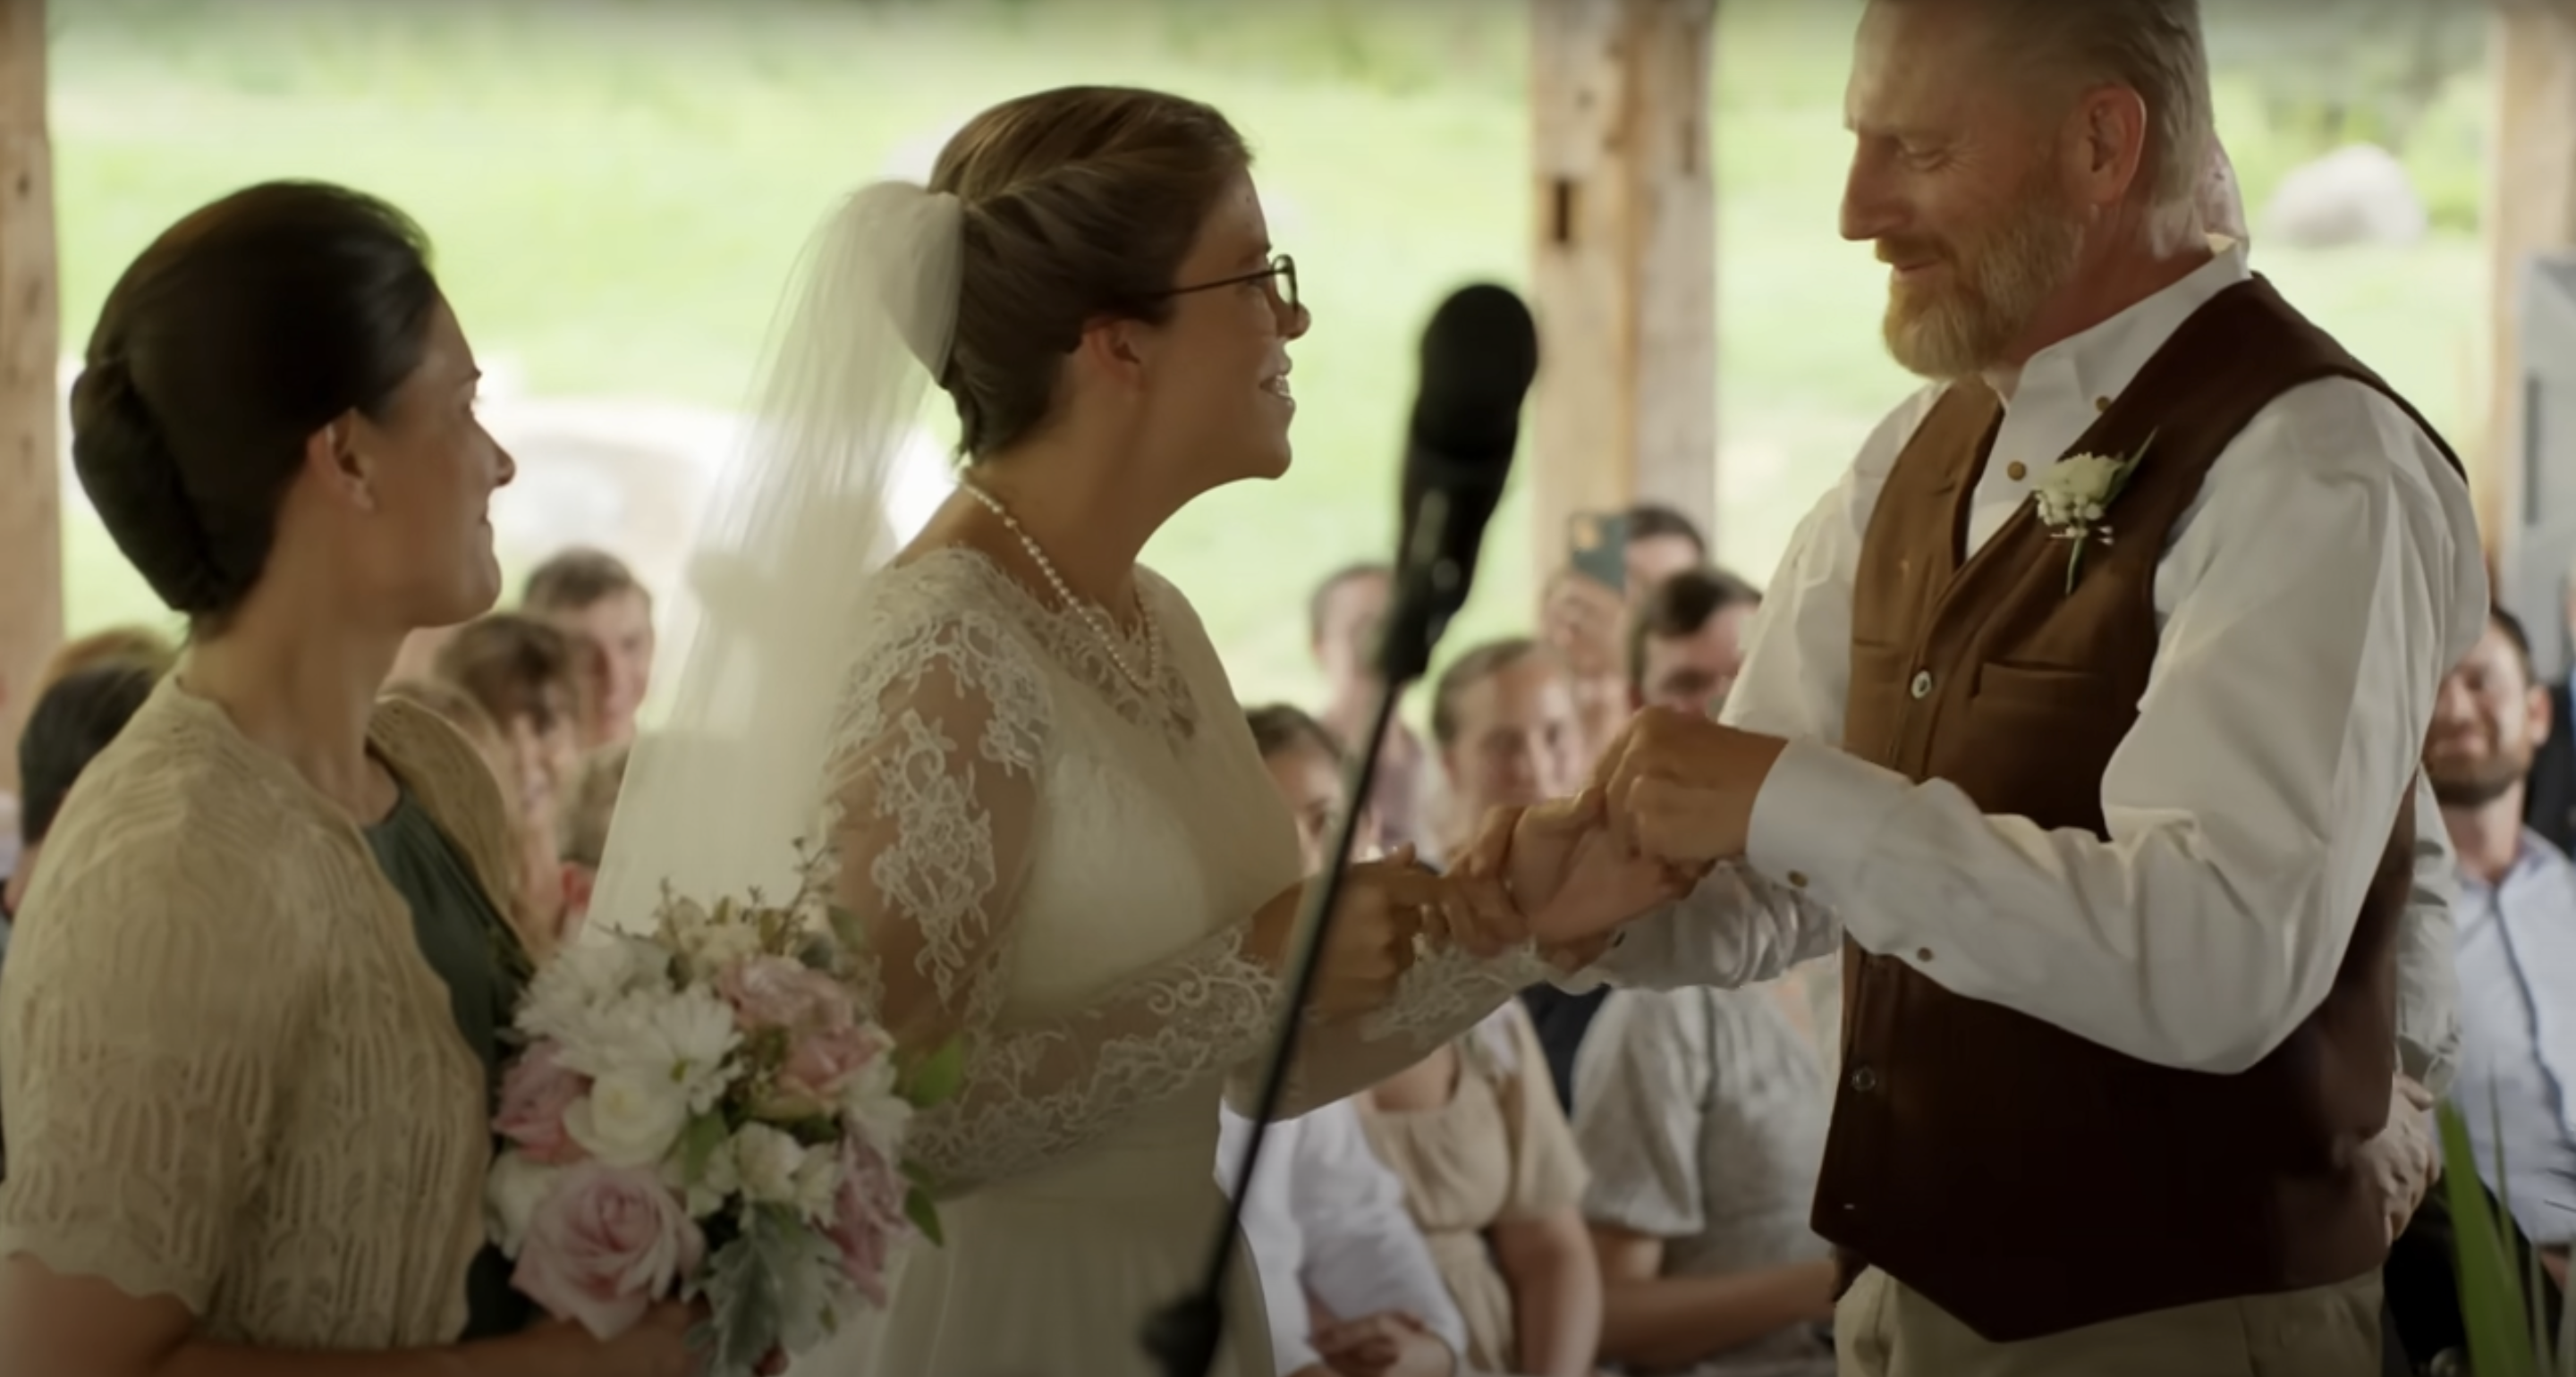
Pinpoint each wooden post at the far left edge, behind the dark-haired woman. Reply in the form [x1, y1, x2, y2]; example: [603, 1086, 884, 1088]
[0, 0, 62, 790]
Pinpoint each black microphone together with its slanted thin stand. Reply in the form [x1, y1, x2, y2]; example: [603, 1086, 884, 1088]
[1144, 286, 1538, 1377]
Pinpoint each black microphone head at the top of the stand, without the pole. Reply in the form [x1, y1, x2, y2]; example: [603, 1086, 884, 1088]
[1378, 286, 1538, 685]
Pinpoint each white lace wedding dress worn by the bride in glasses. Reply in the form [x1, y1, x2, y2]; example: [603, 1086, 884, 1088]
[799, 548, 1540, 1377]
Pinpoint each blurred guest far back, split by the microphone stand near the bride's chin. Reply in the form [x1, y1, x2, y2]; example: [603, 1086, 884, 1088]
[1306, 563, 1437, 855]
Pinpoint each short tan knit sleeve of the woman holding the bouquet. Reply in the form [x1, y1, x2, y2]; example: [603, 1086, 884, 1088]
[0, 813, 311, 1315]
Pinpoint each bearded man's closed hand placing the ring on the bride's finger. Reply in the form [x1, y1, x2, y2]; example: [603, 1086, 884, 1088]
[1592, 708, 1788, 865]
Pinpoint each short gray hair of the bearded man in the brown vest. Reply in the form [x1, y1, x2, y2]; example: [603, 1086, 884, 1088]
[1976, 0, 2216, 206]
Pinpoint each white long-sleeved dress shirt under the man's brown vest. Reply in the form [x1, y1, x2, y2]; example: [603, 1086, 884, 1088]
[1597, 244, 2486, 1073]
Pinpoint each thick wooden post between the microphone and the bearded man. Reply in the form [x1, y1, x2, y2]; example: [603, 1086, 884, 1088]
[1530, 0, 1718, 587]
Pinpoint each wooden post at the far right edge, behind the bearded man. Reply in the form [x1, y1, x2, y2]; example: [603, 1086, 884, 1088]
[2462, 0, 2576, 569]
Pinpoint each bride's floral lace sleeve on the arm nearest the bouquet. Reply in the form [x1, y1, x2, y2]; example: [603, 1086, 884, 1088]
[829, 612, 1277, 1195]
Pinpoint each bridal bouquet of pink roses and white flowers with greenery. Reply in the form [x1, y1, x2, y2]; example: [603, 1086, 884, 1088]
[484, 855, 958, 1377]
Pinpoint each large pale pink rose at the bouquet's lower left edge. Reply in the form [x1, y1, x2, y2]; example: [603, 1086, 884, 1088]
[510, 1161, 706, 1339]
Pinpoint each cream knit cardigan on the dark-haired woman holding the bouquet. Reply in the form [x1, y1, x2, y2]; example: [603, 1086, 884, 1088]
[0, 677, 530, 1351]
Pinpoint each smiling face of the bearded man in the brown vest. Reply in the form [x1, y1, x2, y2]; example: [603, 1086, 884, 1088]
[1842, 0, 2084, 378]
